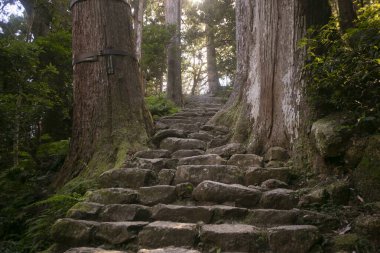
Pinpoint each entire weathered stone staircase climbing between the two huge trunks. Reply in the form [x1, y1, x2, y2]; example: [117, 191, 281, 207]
[52, 97, 336, 253]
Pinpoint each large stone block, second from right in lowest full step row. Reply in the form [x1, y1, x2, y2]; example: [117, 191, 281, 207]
[201, 224, 266, 252]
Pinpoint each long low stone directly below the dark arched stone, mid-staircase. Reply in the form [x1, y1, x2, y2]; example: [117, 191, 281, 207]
[160, 137, 207, 152]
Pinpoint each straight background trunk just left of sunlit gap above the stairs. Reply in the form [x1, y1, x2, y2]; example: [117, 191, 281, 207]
[165, 0, 182, 106]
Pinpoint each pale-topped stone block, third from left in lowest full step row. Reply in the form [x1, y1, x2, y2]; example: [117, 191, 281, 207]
[139, 221, 198, 249]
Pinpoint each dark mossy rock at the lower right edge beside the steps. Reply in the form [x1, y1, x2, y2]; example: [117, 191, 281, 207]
[353, 135, 380, 201]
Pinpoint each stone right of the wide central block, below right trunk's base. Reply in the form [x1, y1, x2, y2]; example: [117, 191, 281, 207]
[245, 167, 292, 185]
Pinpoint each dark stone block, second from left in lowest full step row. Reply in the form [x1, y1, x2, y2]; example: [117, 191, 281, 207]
[95, 222, 149, 245]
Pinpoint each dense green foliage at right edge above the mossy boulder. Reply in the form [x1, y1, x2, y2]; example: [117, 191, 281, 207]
[303, 4, 380, 123]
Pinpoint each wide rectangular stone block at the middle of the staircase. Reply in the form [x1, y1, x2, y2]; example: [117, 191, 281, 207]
[174, 165, 245, 186]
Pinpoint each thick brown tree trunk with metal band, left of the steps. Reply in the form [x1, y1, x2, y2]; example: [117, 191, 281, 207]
[55, 0, 152, 186]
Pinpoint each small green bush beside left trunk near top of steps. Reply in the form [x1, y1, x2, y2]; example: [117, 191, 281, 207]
[145, 95, 179, 119]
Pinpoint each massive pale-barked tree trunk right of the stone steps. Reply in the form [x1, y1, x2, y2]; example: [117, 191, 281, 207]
[213, 0, 330, 153]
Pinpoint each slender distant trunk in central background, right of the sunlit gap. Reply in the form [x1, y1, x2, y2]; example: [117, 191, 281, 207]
[206, 24, 220, 95]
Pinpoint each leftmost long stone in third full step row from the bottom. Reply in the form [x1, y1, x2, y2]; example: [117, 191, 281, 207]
[85, 188, 138, 205]
